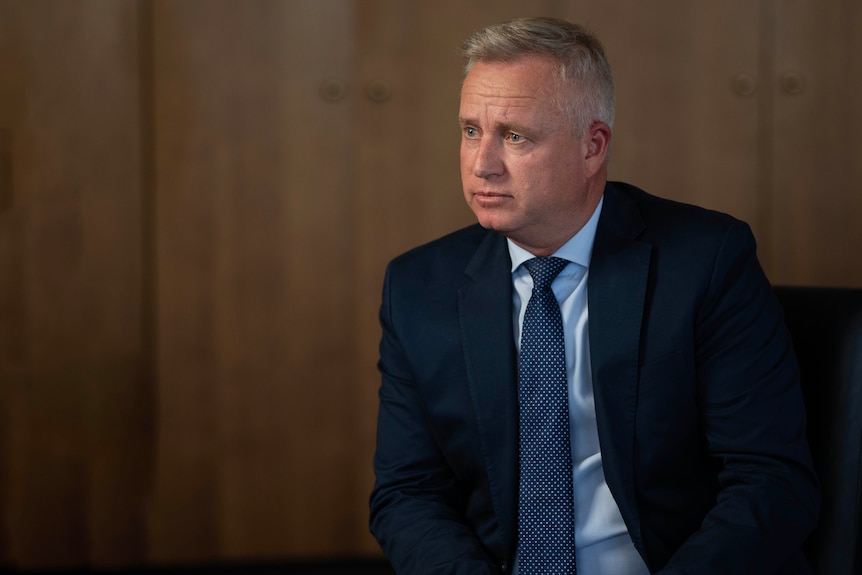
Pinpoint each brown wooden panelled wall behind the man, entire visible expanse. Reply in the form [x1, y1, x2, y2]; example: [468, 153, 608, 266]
[0, 0, 862, 567]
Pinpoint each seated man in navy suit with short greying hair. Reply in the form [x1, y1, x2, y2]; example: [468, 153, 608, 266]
[371, 15, 819, 575]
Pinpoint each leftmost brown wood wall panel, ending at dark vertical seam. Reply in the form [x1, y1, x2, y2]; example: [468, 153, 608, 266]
[0, 1, 154, 566]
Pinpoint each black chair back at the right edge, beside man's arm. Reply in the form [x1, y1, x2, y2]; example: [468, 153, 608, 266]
[775, 286, 862, 575]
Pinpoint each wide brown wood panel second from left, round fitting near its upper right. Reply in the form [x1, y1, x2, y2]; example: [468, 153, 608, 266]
[151, 0, 362, 562]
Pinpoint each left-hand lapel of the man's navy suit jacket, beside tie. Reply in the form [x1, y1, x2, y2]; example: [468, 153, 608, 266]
[458, 232, 518, 553]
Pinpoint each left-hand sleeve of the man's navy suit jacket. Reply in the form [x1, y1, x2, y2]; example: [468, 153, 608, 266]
[370, 265, 500, 575]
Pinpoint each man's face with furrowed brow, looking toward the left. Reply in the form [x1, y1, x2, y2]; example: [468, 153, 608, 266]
[460, 56, 610, 255]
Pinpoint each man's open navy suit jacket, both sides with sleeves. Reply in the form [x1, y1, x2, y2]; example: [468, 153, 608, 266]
[371, 183, 818, 575]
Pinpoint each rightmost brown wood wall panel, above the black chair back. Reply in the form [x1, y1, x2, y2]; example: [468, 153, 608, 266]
[769, 0, 862, 287]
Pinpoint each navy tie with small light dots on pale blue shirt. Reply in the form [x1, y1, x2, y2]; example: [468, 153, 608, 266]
[518, 257, 575, 575]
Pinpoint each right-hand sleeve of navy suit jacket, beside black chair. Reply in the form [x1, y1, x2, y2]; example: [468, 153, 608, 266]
[660, 219, 819, 575]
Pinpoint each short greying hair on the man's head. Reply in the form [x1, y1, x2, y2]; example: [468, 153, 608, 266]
[461, 18, 614, 136]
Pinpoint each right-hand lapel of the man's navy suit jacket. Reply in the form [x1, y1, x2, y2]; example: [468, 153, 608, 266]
[588, 184, 651, 548]
